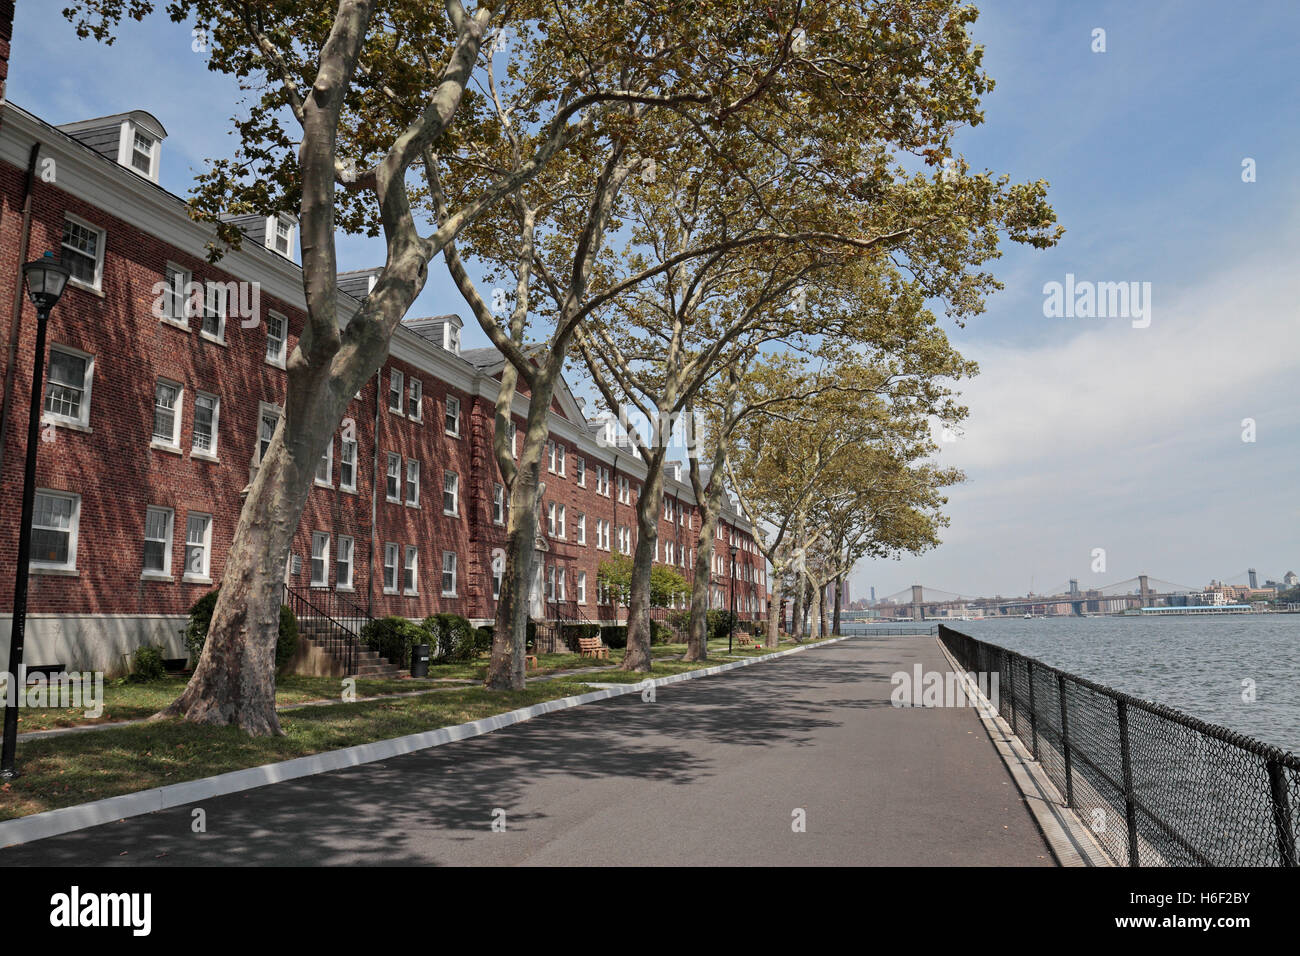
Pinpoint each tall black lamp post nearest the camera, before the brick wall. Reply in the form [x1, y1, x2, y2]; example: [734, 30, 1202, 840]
[0, 252, 72, 780]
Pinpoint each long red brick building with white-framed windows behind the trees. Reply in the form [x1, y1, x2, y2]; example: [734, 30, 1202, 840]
[0, 89, 767, 671]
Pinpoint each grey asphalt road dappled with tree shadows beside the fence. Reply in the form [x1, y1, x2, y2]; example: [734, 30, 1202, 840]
[0, 637, 1053, 866]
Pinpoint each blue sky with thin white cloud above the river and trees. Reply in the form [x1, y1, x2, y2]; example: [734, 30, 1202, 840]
[8, 0, 1300, 597]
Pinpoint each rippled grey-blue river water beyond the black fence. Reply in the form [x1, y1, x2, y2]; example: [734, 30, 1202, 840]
[945, 614, 1300, 753]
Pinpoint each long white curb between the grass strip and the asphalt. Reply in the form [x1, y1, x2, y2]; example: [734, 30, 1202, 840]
[0, 637, 849, 847]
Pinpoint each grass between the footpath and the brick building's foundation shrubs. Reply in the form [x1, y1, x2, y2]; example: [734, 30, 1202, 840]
[0, 674, 472, 734]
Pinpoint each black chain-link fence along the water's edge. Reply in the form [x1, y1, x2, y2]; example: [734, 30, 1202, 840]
[939, 624, 1300, 866]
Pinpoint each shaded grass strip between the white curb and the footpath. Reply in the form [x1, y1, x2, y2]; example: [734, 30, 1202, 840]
[0, 680, 590, 819]
